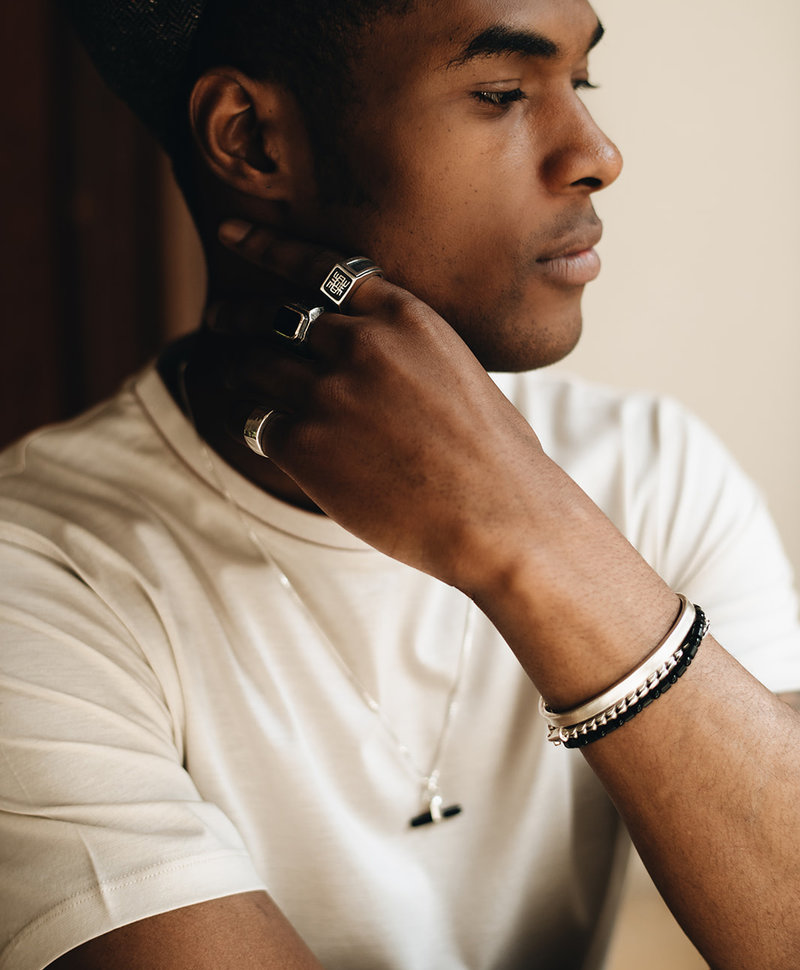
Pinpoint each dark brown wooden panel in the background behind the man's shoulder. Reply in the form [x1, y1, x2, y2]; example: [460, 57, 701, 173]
[0, 0, 164, 444]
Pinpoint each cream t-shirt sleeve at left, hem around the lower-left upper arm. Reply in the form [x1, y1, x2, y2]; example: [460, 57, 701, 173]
[0, 526, 264, 970]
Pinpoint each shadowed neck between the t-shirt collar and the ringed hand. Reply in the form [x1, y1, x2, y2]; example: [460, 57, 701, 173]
[158, 330, 321, 514]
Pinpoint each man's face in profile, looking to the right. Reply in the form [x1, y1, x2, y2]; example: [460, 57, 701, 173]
[298, 0, 621, 370]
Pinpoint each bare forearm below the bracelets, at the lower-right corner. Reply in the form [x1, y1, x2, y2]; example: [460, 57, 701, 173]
[584, 637, 800, 970]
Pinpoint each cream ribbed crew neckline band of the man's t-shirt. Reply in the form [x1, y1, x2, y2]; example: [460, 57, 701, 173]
[132, 364, 378, 555]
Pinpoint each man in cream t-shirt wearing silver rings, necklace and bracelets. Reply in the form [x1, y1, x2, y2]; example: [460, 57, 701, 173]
[0, 0, 800, 970]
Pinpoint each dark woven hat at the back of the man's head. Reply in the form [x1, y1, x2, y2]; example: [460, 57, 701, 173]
[62, 0, 208, 147]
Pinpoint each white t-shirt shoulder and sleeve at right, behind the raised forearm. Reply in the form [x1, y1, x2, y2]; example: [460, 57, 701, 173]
[498, 373, 800, 690]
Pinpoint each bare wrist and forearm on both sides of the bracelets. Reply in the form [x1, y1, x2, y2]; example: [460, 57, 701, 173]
[476, 456, 800, 970]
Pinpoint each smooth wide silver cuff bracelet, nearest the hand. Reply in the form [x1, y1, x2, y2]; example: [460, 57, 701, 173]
[539, 593, 696, 728]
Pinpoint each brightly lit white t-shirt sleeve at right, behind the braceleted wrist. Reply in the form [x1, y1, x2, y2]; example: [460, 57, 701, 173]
[634, 400, 800, 693]
